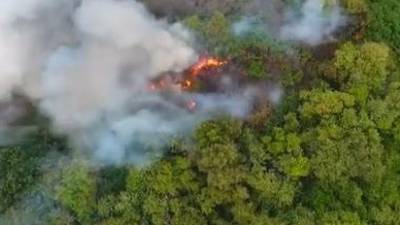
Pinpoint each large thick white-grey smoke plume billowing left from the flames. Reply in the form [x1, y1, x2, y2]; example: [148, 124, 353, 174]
[0, 0, 256, 164]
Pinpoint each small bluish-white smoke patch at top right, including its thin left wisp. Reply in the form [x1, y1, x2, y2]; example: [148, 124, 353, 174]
[232, 0, 346, 45]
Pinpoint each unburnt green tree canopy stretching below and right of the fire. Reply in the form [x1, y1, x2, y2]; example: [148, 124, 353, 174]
[0, 0, 400, 225]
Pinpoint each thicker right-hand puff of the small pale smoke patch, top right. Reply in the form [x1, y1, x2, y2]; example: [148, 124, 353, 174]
[280, 0, 345, 45]
